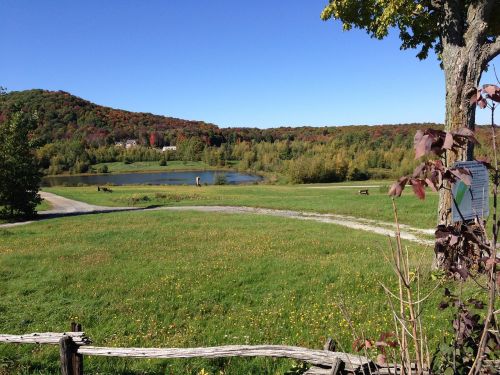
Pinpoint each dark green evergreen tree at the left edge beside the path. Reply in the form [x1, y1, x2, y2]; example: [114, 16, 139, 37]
[0, 111, 41, 217]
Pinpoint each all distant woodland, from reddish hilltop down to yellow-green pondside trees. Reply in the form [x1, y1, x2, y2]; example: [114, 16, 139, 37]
[0, 90, 490, 183]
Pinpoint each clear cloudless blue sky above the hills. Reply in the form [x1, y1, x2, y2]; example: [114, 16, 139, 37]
[0, 0, 500, 127]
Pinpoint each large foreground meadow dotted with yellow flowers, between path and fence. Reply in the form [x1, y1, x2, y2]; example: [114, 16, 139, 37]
[0, 210, 454, 374]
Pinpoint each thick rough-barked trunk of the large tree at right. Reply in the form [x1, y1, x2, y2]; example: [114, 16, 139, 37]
[437, 0, 500, 229]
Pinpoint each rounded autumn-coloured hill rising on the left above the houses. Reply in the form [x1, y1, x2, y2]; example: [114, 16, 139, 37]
[0, 90, 217, 145]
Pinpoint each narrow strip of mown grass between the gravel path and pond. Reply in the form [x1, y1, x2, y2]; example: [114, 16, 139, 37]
[45, 182, 438, 228]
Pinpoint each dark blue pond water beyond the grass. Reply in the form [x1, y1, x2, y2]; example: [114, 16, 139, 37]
[42, 171, 262, 186]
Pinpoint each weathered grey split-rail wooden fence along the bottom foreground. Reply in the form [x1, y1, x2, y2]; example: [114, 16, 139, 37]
[4, 323, 496, 375]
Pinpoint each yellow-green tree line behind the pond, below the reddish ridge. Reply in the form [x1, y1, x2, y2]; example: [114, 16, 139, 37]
[30, 127, 489, 183]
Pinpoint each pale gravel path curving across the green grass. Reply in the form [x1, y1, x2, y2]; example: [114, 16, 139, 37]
[0, 192, 434, 245]
